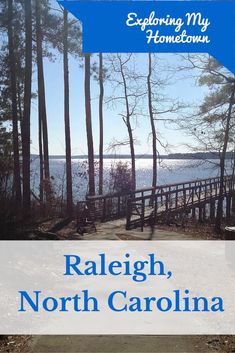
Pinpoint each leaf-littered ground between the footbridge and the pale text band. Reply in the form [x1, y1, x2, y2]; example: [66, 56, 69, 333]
[24, 213, 235, 240]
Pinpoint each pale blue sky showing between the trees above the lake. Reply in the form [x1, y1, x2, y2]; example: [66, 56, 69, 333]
[31, 1, 209, 155]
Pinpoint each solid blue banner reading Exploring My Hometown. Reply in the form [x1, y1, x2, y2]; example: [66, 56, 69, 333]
[59, 0, 235, 73]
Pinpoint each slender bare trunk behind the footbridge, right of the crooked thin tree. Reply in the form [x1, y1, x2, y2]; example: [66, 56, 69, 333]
[147, 53, 157, 188]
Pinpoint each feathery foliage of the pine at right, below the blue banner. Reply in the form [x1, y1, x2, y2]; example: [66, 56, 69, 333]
[193, 57, 235, 152]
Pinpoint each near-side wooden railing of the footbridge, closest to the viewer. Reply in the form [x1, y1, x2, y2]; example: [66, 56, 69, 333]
[126, 176, 235, 229]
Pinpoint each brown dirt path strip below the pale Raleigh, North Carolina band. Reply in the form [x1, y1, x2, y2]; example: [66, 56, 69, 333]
[25, 335, 219, 353]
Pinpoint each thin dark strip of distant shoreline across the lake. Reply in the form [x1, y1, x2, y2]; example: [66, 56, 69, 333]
[31, 152, 234, 160]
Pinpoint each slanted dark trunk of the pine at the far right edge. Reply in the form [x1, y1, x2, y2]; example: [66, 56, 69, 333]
[215, 83, 235, 234]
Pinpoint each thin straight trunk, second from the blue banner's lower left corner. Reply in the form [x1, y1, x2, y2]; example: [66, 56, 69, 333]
[99, 53, 104, 195]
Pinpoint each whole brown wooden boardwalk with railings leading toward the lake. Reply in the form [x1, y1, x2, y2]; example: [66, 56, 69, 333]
[81, 175, 235, 230]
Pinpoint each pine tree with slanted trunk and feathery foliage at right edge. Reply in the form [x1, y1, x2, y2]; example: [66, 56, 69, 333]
[180, 55, 235, 233]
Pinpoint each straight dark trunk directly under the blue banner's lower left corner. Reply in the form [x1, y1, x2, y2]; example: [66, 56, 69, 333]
[85, 54, 95, 196]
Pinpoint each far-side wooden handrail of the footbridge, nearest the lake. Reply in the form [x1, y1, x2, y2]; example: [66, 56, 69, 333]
[81, 175, 235, 222]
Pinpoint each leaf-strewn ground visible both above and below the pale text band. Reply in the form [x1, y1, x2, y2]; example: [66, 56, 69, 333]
[0, 219, 235, 353]
